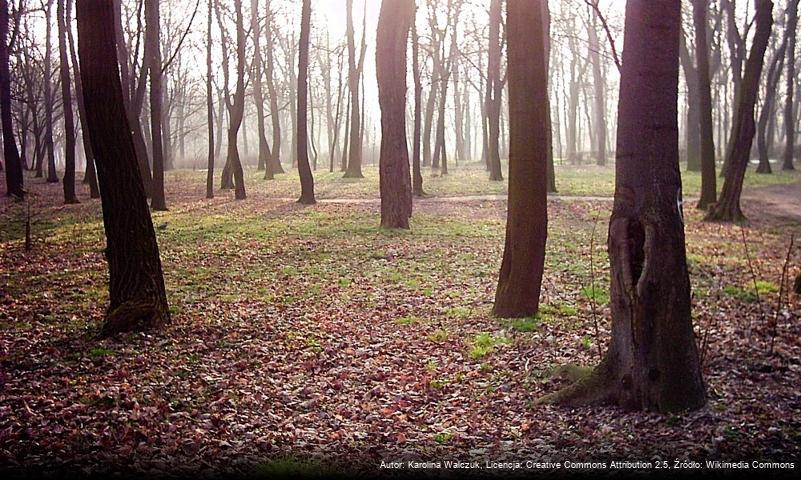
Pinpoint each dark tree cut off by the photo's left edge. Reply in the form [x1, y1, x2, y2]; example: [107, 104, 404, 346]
[0, 0, 25, 198]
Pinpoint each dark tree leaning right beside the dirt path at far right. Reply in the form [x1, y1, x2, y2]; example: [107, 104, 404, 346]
[706, 0, 773, 222]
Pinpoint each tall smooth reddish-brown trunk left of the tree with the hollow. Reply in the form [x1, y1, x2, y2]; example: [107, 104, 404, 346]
[494, 0, 548, 317]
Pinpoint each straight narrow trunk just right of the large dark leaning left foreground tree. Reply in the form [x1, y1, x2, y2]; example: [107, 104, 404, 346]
[145, 0, 167, 211]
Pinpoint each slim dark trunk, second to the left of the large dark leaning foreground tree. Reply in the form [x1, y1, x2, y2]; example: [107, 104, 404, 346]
[56, 1, 79, 204]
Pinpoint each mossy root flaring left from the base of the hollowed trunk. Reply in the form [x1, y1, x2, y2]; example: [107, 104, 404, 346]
[535, 363, 614, 407]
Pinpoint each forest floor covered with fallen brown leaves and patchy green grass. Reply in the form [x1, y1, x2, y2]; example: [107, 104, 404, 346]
[0, 167, 801, 475]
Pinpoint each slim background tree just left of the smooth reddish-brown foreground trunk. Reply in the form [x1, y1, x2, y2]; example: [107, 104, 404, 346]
[485, 0, 503, 181]
